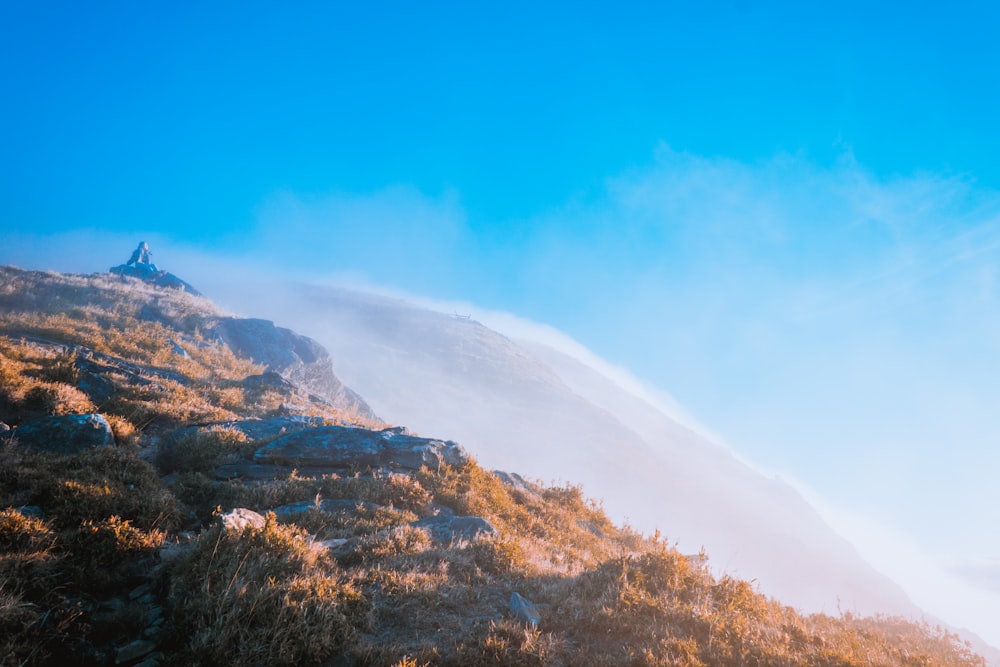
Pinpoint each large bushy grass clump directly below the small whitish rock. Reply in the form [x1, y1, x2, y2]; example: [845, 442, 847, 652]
[170, 514, 367, 665]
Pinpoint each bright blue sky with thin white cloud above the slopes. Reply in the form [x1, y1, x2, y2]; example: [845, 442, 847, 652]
[0, 1, 1000, 641]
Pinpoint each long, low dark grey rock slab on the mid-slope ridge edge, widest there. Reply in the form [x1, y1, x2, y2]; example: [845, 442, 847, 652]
[254, 426, 468, 470]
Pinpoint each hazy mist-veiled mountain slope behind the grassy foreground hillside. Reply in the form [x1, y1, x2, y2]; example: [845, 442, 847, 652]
[209, 286, 918, 614]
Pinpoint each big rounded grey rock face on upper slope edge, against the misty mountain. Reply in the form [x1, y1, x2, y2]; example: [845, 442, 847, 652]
[208, 317, 375, 418]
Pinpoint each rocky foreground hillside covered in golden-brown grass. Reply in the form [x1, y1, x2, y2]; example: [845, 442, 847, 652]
[0, 268, 984, 667]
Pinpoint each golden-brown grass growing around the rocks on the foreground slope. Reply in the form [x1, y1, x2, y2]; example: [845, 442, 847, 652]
[0, 268, 985, 667]
